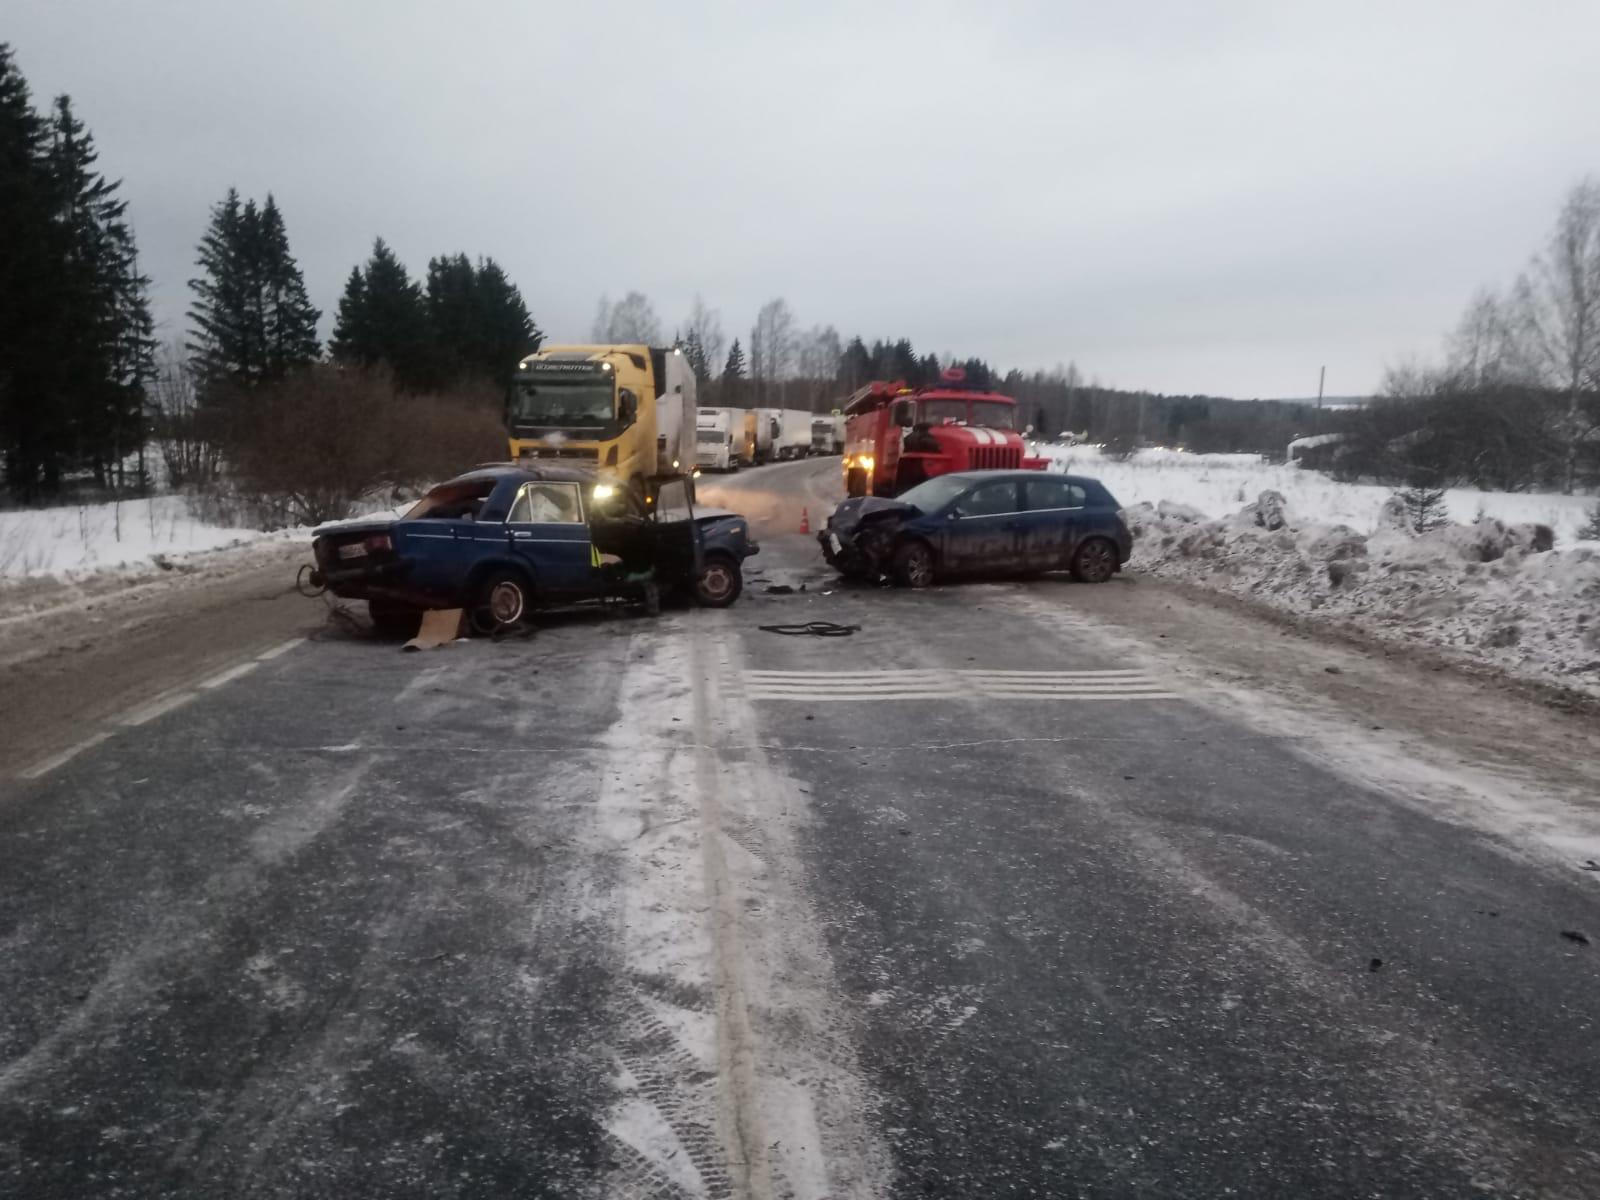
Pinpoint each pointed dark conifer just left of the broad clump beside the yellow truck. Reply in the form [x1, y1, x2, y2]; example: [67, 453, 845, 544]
[330, 238, 438, 392]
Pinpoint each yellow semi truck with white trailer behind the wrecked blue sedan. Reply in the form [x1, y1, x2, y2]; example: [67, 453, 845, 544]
[506, 346, 696, 496]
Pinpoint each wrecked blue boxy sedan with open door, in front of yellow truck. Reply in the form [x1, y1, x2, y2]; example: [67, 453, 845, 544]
[312, 464, 760, 637]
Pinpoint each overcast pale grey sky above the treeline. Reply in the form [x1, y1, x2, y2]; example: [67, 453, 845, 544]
[12, 0, 1600, 397]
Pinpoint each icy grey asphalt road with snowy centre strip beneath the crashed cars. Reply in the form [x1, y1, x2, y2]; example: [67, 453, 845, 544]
[0, 461, 1600, 1197]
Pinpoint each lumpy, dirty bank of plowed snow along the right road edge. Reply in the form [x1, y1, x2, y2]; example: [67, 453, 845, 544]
[1125, 491, 1600, 696]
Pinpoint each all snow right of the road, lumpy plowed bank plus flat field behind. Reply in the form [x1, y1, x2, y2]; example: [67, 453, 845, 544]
[1043, 446, 1600, 698]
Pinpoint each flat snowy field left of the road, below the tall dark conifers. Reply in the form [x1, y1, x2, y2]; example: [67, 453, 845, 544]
[0, 496, 277, 579]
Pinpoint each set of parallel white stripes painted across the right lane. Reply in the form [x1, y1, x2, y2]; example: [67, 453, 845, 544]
[744, 669, 1181, 701]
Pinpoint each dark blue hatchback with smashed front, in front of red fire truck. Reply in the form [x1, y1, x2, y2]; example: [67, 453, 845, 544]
[818, 470, 1133, 587]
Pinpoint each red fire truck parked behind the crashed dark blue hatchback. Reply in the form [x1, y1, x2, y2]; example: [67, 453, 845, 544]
[845, 366, 1045, 496]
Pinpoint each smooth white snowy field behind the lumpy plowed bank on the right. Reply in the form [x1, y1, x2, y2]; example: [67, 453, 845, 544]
[1035, 445, 1597, 547]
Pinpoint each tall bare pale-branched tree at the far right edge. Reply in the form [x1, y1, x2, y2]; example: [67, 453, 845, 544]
[1517, 179, 1600, 493]
